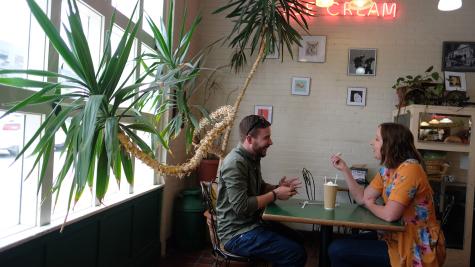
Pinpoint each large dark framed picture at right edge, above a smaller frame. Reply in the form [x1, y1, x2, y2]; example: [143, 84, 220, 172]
[442, 42, 475, 72]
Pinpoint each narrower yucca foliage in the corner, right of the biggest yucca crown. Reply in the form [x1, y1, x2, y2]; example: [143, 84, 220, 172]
[141, 1, 213, 152]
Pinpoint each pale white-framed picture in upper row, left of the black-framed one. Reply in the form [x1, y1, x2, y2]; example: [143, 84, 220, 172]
[298, 36, 327, 63]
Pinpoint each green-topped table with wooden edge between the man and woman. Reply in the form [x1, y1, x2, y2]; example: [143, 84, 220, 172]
[262, 199, 404, 267]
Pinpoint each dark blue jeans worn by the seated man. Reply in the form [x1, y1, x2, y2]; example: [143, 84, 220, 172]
[224, 226, 307, 267]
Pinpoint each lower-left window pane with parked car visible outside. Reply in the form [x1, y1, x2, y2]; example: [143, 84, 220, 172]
[0, 111, 41, 236]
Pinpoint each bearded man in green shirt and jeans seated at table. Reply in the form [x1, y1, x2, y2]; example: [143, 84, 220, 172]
[216, 115, 307, 266]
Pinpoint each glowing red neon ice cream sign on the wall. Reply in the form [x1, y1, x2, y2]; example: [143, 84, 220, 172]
[306, 1, 397, 18]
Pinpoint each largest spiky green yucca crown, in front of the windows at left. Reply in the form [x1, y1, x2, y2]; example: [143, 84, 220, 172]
[0, 0, 182, 210]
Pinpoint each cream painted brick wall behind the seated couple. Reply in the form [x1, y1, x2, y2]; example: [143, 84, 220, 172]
[193, 0, 475, 201]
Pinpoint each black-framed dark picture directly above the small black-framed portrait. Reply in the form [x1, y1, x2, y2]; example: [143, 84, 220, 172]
[348, 48, 376, 76]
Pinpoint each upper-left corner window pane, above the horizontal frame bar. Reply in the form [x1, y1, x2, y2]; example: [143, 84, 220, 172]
[0, 0, 47, 81]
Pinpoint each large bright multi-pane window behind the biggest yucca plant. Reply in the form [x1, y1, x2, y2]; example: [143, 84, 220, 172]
[0, 0, 163, 242]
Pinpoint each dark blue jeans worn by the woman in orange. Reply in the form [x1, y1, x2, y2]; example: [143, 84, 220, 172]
[328, 232, 391, 267]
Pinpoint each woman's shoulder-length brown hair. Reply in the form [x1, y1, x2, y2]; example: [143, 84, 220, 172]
[379, 122, 424, 169]
